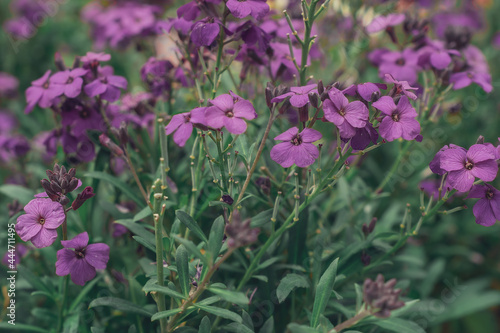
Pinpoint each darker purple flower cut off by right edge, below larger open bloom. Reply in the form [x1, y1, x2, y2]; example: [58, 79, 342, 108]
[467, 184, 500, 227]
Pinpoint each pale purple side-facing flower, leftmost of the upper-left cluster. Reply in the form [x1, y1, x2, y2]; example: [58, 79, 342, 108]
[24, 70, 64, 113]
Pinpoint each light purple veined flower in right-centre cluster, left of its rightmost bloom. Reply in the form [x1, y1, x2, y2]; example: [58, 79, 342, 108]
[323, 88, 368, 139]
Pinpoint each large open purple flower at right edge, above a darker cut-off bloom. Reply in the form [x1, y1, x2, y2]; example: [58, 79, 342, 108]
[440, 144, 498, 192]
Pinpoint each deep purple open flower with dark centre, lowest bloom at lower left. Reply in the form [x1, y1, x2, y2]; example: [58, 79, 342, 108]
[56, 232, 109, 286]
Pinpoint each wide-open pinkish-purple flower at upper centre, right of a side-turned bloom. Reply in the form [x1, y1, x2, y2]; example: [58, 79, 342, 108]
[205, 91, 257, 134]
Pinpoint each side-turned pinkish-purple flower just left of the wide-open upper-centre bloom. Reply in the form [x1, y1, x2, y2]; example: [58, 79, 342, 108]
[165, 107, 207, 147]
